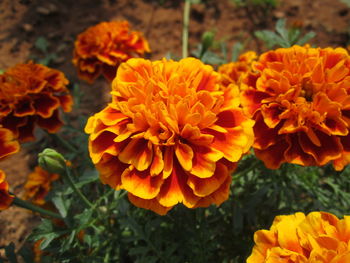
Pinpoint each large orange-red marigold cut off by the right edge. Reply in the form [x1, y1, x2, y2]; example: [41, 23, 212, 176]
[241, 46, 350, 170]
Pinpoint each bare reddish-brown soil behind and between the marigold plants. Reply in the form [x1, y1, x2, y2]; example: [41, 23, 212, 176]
[0, 0, 350, 255]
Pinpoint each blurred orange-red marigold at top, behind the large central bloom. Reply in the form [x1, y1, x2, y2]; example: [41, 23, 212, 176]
[73, 21, 151, 83]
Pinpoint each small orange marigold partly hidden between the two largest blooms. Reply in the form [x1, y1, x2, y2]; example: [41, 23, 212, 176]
[218, 51, 257, 86]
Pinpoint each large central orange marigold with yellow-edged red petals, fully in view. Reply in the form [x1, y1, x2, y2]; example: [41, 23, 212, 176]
[85, 58, 253, 214]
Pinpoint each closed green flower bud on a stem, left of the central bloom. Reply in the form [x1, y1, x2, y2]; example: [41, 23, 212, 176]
[38, 148, 66, 174]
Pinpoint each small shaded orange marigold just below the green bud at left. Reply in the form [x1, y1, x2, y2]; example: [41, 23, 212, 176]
[24, 166, 60, 205]
